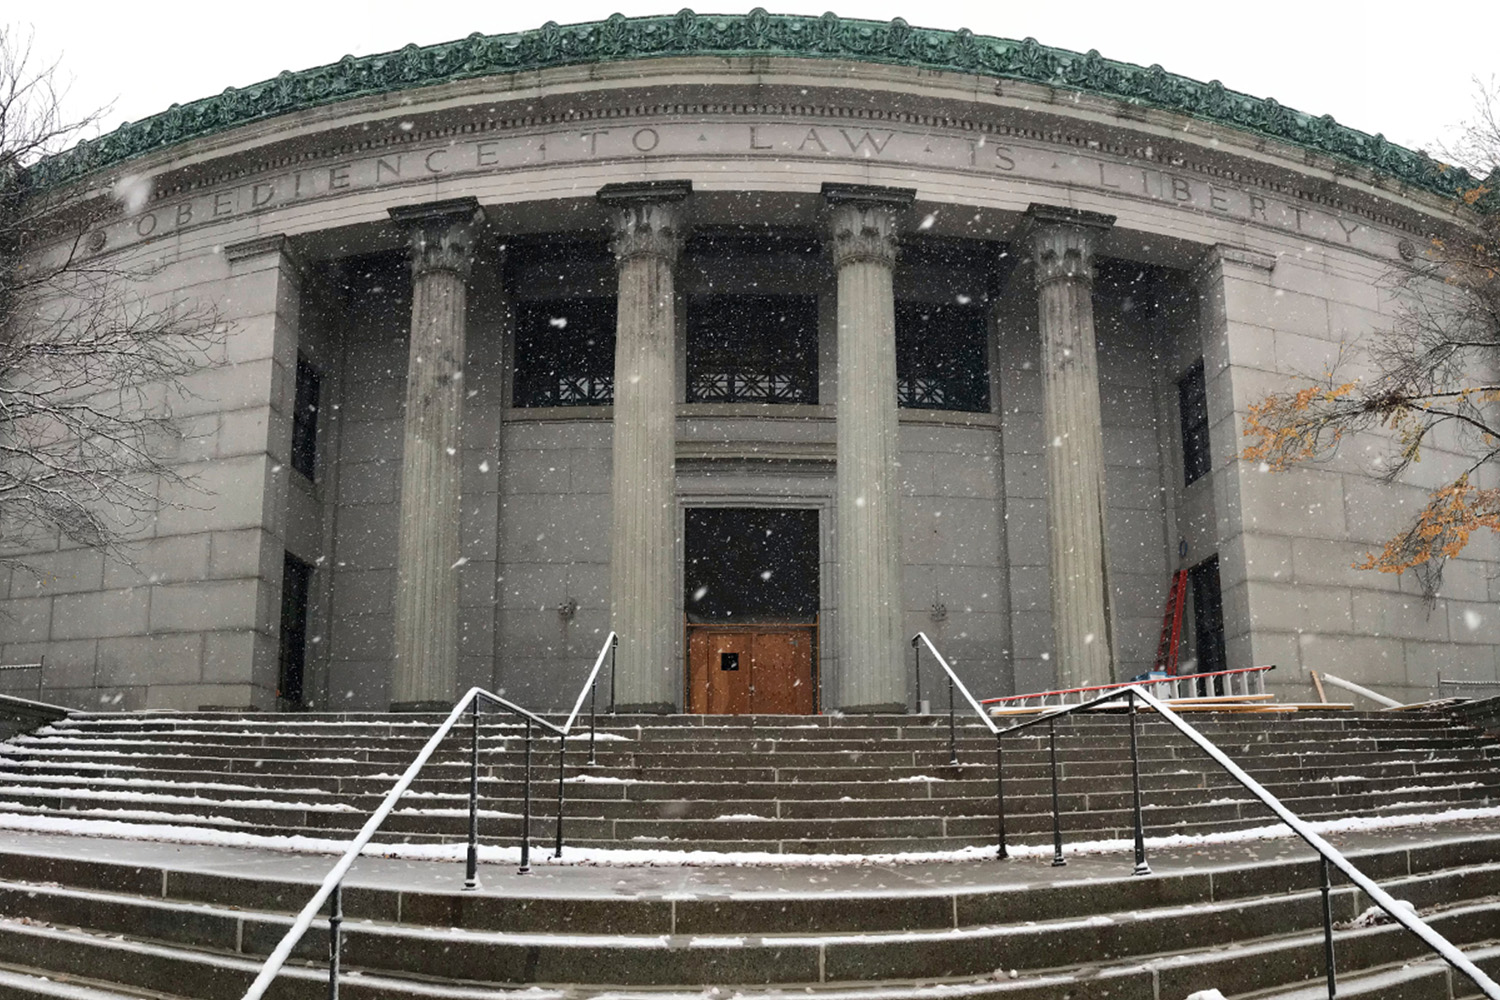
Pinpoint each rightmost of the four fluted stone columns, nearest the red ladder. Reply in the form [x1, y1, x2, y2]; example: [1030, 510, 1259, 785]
[1025, 205, 1115, 688]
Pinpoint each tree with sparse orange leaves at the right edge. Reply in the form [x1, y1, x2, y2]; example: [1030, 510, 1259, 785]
[1241, 87, 1500, 594]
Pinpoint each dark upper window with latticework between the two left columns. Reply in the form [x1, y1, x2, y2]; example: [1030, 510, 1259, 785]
[515, 298, 615, 406]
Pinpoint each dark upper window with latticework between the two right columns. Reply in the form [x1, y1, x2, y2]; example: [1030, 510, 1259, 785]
[896, 301, 990, 414]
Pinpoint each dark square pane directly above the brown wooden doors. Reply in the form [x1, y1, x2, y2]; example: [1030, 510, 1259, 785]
[683, 507, 818, 624]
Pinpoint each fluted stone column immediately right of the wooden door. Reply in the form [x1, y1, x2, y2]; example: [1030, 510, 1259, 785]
[824, 184, 915, 712]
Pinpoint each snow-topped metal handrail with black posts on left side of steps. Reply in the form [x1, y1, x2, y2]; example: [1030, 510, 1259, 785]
[242, 633, 620, 1000]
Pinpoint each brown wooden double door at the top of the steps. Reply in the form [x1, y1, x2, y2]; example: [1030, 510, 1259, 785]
[687, 627, 818, 715]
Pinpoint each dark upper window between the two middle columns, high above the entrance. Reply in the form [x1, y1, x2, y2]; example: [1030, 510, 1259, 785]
[687, 295, 818, 403]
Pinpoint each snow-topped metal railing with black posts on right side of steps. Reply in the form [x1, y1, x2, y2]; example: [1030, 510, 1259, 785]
[912, 633, 1500, 1000]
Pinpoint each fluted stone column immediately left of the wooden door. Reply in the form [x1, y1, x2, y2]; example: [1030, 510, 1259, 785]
[599, 181, 693, 712]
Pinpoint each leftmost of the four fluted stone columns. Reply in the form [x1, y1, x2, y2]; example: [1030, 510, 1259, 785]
[390, 198, 485, 712]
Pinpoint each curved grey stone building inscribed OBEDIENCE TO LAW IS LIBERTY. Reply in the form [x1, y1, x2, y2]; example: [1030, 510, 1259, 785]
[0, 12, 1500, 711]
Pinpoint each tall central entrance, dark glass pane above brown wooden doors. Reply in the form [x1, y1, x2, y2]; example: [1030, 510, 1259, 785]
[683, 507, 818, 715]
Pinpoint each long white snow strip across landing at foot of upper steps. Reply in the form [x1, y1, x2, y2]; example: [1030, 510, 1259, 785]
[0, 807, 1500, 867]
